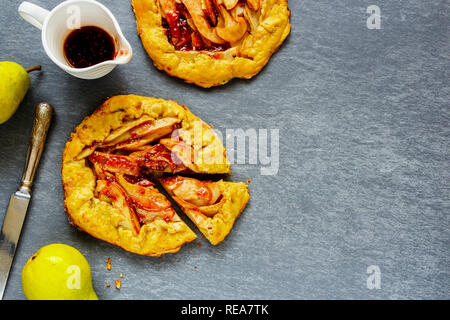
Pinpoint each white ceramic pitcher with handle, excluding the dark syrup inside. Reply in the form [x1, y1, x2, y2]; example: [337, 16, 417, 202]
[19, 0, 133, 79]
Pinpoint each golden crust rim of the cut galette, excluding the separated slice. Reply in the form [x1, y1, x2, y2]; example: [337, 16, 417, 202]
[62, 95, 229, 256]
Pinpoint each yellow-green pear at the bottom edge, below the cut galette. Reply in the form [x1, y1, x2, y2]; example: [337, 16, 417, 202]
[22, 243, 98, 300]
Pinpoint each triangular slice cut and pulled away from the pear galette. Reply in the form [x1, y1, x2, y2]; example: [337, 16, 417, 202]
[160, 176, 250, 245]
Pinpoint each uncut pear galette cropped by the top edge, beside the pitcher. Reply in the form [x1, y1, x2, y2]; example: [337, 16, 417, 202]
[132, 0, 291, 88]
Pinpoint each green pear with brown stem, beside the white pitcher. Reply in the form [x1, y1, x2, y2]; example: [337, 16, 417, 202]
[0, 61, 41, 124]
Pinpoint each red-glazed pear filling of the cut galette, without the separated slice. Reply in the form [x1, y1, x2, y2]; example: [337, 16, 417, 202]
[87, 118, 188, 230]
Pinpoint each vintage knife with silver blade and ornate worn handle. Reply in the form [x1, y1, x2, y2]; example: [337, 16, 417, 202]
[0, 103, 53, 299]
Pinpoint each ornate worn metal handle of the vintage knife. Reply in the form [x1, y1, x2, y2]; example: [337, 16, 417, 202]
[19, 103, 54, 192]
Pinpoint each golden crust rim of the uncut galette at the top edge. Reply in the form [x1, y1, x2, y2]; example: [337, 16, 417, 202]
[132, 0, 291, 88]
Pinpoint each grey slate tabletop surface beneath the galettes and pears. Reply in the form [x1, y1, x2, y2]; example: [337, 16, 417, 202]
[0, 0, 450, 299]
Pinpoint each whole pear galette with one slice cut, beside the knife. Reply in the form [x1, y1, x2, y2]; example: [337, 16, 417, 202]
[62, 95, 249, 256]
